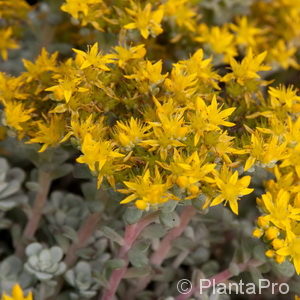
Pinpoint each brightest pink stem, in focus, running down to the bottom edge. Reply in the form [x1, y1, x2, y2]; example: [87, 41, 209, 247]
[99, 212, 158, 300]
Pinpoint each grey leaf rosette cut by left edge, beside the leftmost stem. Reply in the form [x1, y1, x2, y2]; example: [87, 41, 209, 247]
[0, 158, 27, 211]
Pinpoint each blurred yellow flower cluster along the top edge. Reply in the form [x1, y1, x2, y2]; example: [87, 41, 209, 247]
[61, 0, 300, 69]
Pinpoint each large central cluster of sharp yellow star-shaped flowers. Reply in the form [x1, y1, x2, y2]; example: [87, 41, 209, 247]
[1, 43, 263, 213]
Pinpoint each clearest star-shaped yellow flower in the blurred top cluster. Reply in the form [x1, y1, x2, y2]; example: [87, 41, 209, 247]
[124, 3, 164, 39]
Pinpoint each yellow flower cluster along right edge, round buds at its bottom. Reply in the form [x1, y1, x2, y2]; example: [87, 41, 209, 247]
[247, 86, 300, 274]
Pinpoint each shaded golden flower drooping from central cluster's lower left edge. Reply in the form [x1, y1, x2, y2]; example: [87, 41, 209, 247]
[27, 115, 66, 152]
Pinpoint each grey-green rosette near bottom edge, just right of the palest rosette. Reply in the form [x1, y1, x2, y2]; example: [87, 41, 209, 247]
[65, 261, 99, 300]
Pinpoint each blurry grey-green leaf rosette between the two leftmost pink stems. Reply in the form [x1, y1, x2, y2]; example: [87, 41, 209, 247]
[44, 191, 89, 249]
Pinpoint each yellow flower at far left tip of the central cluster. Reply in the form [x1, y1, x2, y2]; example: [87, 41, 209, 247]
[4, 101, 34, 131]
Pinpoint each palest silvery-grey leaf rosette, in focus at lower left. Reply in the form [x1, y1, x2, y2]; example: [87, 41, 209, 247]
[25, 243, 66, 281]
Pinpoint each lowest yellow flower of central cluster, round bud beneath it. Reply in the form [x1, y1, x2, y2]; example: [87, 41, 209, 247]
[119, 168, 176, 210]
